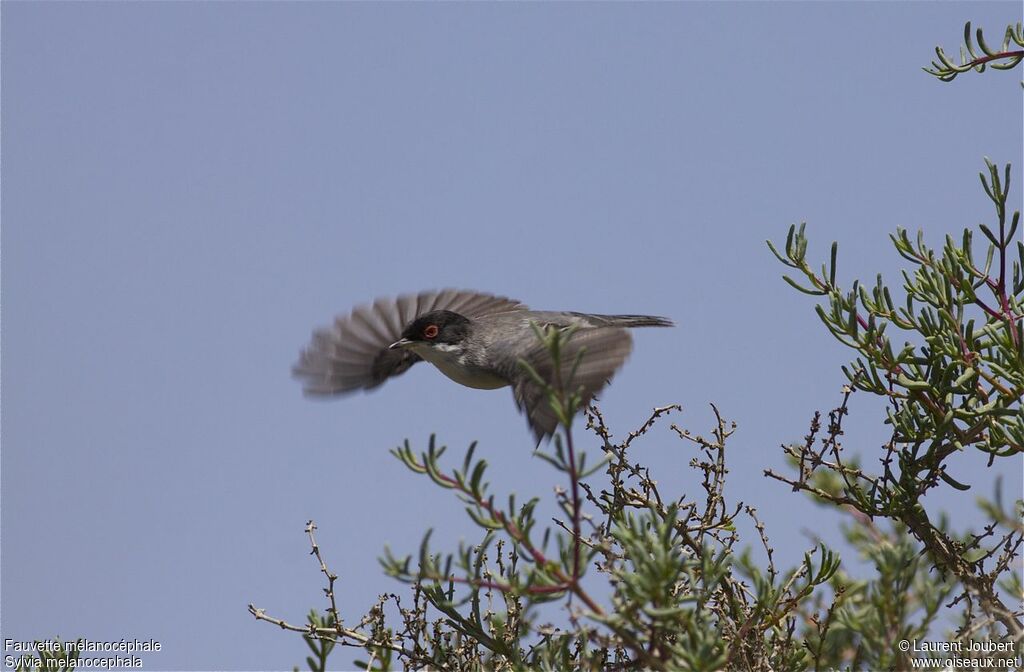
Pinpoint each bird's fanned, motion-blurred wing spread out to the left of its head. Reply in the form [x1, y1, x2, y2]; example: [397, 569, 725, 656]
[292, 289, 526, 395]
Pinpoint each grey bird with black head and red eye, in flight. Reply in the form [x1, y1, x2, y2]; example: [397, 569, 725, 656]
[292, 289, 674, 443]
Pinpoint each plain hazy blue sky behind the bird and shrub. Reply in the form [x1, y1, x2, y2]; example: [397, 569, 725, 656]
[0, 2, 1024, 670]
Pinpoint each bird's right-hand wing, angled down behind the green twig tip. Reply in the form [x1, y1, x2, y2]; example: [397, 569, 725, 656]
[512, 328, 633, 443]
